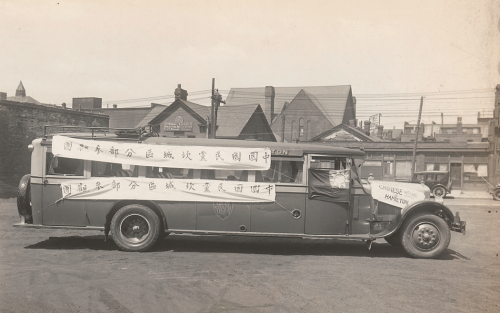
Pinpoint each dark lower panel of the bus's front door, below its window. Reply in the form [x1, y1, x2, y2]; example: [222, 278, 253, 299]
[306, 198, 349, 235]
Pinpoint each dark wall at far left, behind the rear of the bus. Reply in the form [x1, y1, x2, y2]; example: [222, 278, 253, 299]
[0, 100, 109, 188]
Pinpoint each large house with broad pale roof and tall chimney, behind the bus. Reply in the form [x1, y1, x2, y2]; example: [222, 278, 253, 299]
[226, 85, 356, 142]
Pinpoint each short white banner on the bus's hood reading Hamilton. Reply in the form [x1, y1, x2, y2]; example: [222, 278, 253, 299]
[370, 180, 425, 209]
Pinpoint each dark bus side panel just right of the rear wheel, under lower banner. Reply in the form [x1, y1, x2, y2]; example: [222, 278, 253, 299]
[161, 202, 196, 230]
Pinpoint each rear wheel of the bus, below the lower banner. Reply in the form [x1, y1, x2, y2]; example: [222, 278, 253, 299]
[110, 204, 161, 252]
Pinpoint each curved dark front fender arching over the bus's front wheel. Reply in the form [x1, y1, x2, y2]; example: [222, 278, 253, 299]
[377, 200, 455, 238]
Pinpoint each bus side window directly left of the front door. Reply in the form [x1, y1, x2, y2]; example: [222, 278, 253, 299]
[262, 157, 304, 184]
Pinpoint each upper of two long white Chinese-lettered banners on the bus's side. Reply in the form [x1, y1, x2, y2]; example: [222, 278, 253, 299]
[52, 136, 271, 170]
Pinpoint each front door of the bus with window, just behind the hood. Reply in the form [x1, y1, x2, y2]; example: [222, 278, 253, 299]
[305, 156, 352, 235]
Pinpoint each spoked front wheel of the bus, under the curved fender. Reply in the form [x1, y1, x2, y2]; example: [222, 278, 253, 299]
[401, 214, 451, 259]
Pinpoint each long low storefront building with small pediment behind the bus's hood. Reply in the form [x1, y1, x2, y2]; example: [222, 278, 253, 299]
[311, 125, 490, 190]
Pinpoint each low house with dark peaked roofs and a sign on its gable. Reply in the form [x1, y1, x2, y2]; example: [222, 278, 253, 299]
[136, 85, 276, 141]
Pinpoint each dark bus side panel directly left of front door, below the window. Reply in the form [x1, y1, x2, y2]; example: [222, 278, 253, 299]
[251, 187, 307, 234]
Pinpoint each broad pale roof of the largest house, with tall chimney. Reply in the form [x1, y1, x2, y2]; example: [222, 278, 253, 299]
[226, 85, 351, 125]
